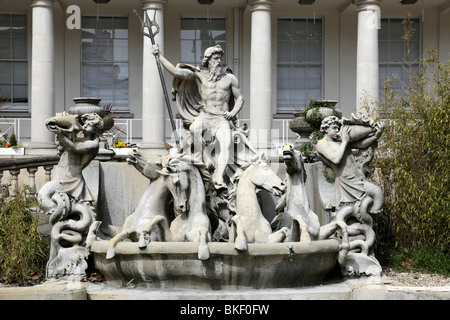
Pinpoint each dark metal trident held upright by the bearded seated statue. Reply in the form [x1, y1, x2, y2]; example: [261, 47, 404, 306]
[133, 9, 181, 153]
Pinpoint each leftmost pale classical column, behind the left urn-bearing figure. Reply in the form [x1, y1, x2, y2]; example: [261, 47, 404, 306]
[29, 0, 56, 153]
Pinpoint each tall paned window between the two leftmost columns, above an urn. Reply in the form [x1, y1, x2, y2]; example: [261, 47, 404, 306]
[81, 17, 130, 112]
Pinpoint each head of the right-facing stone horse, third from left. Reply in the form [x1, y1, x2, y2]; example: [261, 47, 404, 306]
[246, 154, 285, 196]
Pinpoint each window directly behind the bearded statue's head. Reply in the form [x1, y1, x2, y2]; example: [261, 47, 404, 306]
[180, 18, 227, 66]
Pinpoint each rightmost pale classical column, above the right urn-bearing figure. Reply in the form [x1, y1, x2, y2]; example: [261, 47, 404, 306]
[352, 0, 382, 114]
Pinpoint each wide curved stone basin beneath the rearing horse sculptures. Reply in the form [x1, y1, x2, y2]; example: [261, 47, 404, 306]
[90, 239, 340, 290]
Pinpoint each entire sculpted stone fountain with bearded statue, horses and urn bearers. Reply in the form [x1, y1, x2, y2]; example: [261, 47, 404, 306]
[39, 10, 383, 290]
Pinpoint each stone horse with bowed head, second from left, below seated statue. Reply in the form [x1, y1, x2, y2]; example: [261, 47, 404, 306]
[139, 154, 218, 260]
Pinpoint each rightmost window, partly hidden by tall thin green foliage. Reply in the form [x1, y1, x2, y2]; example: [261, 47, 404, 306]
[378, 19, 420, 96]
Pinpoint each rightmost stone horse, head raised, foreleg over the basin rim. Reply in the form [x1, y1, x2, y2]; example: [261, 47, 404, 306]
[283, 144, 349, 261]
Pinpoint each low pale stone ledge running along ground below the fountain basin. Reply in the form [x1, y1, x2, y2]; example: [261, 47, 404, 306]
[0, 277, 450, 301]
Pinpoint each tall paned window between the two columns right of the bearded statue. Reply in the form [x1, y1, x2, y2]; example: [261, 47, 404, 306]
[277, 19, 323, 113]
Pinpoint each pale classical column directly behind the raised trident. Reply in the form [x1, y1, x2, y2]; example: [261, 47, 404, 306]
[140, 0, 166, 153]
